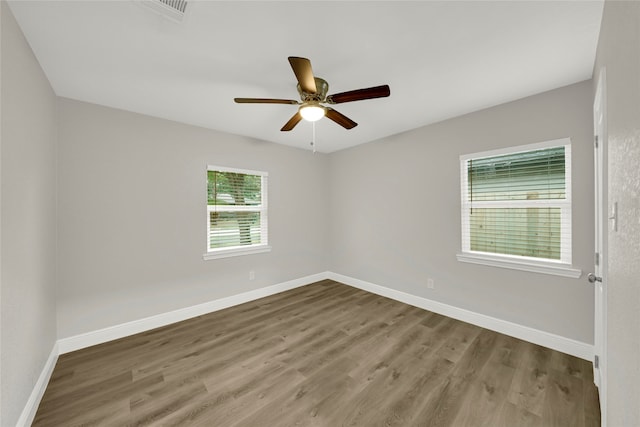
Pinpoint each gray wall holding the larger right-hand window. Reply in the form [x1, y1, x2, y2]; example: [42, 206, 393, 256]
[330, 81, 594, 343]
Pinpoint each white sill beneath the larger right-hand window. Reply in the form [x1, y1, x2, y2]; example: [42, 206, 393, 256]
[456, 252, 582, 279]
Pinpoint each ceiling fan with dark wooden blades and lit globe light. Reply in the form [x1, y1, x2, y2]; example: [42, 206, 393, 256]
[234, 56, 391, 131]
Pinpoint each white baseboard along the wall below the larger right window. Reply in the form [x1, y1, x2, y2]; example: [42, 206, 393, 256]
[327, 272, 594, 361]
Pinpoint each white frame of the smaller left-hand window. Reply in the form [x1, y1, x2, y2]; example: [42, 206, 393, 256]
[202, 165, 271, 261]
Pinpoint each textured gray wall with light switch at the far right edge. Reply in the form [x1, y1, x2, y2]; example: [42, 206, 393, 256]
[594, 1, 640, 426]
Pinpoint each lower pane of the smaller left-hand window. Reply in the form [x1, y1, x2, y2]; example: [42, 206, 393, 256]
[209, 212, 262, 249]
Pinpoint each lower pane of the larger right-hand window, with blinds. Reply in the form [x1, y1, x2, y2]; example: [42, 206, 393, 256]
[469, 207, 562, 260]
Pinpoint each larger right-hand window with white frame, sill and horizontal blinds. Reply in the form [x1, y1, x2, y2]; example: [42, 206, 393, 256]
[458, 139, 580, 277]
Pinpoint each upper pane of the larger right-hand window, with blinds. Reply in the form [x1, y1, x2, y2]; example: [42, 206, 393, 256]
[467, 147, 566, 202]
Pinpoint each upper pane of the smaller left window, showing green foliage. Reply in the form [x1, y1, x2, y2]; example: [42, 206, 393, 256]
[207, 171, 262, 206]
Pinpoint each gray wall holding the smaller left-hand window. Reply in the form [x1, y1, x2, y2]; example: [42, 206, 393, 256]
[57, 99, 329, 338]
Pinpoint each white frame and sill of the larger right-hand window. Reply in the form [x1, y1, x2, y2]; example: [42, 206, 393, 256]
[456, 138, 582, 278]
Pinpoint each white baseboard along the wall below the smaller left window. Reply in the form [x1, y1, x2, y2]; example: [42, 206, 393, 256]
[58, 273, 328, 354]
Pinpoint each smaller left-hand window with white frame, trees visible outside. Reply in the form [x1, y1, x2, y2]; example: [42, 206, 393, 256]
[204, 166, 271, 259]
